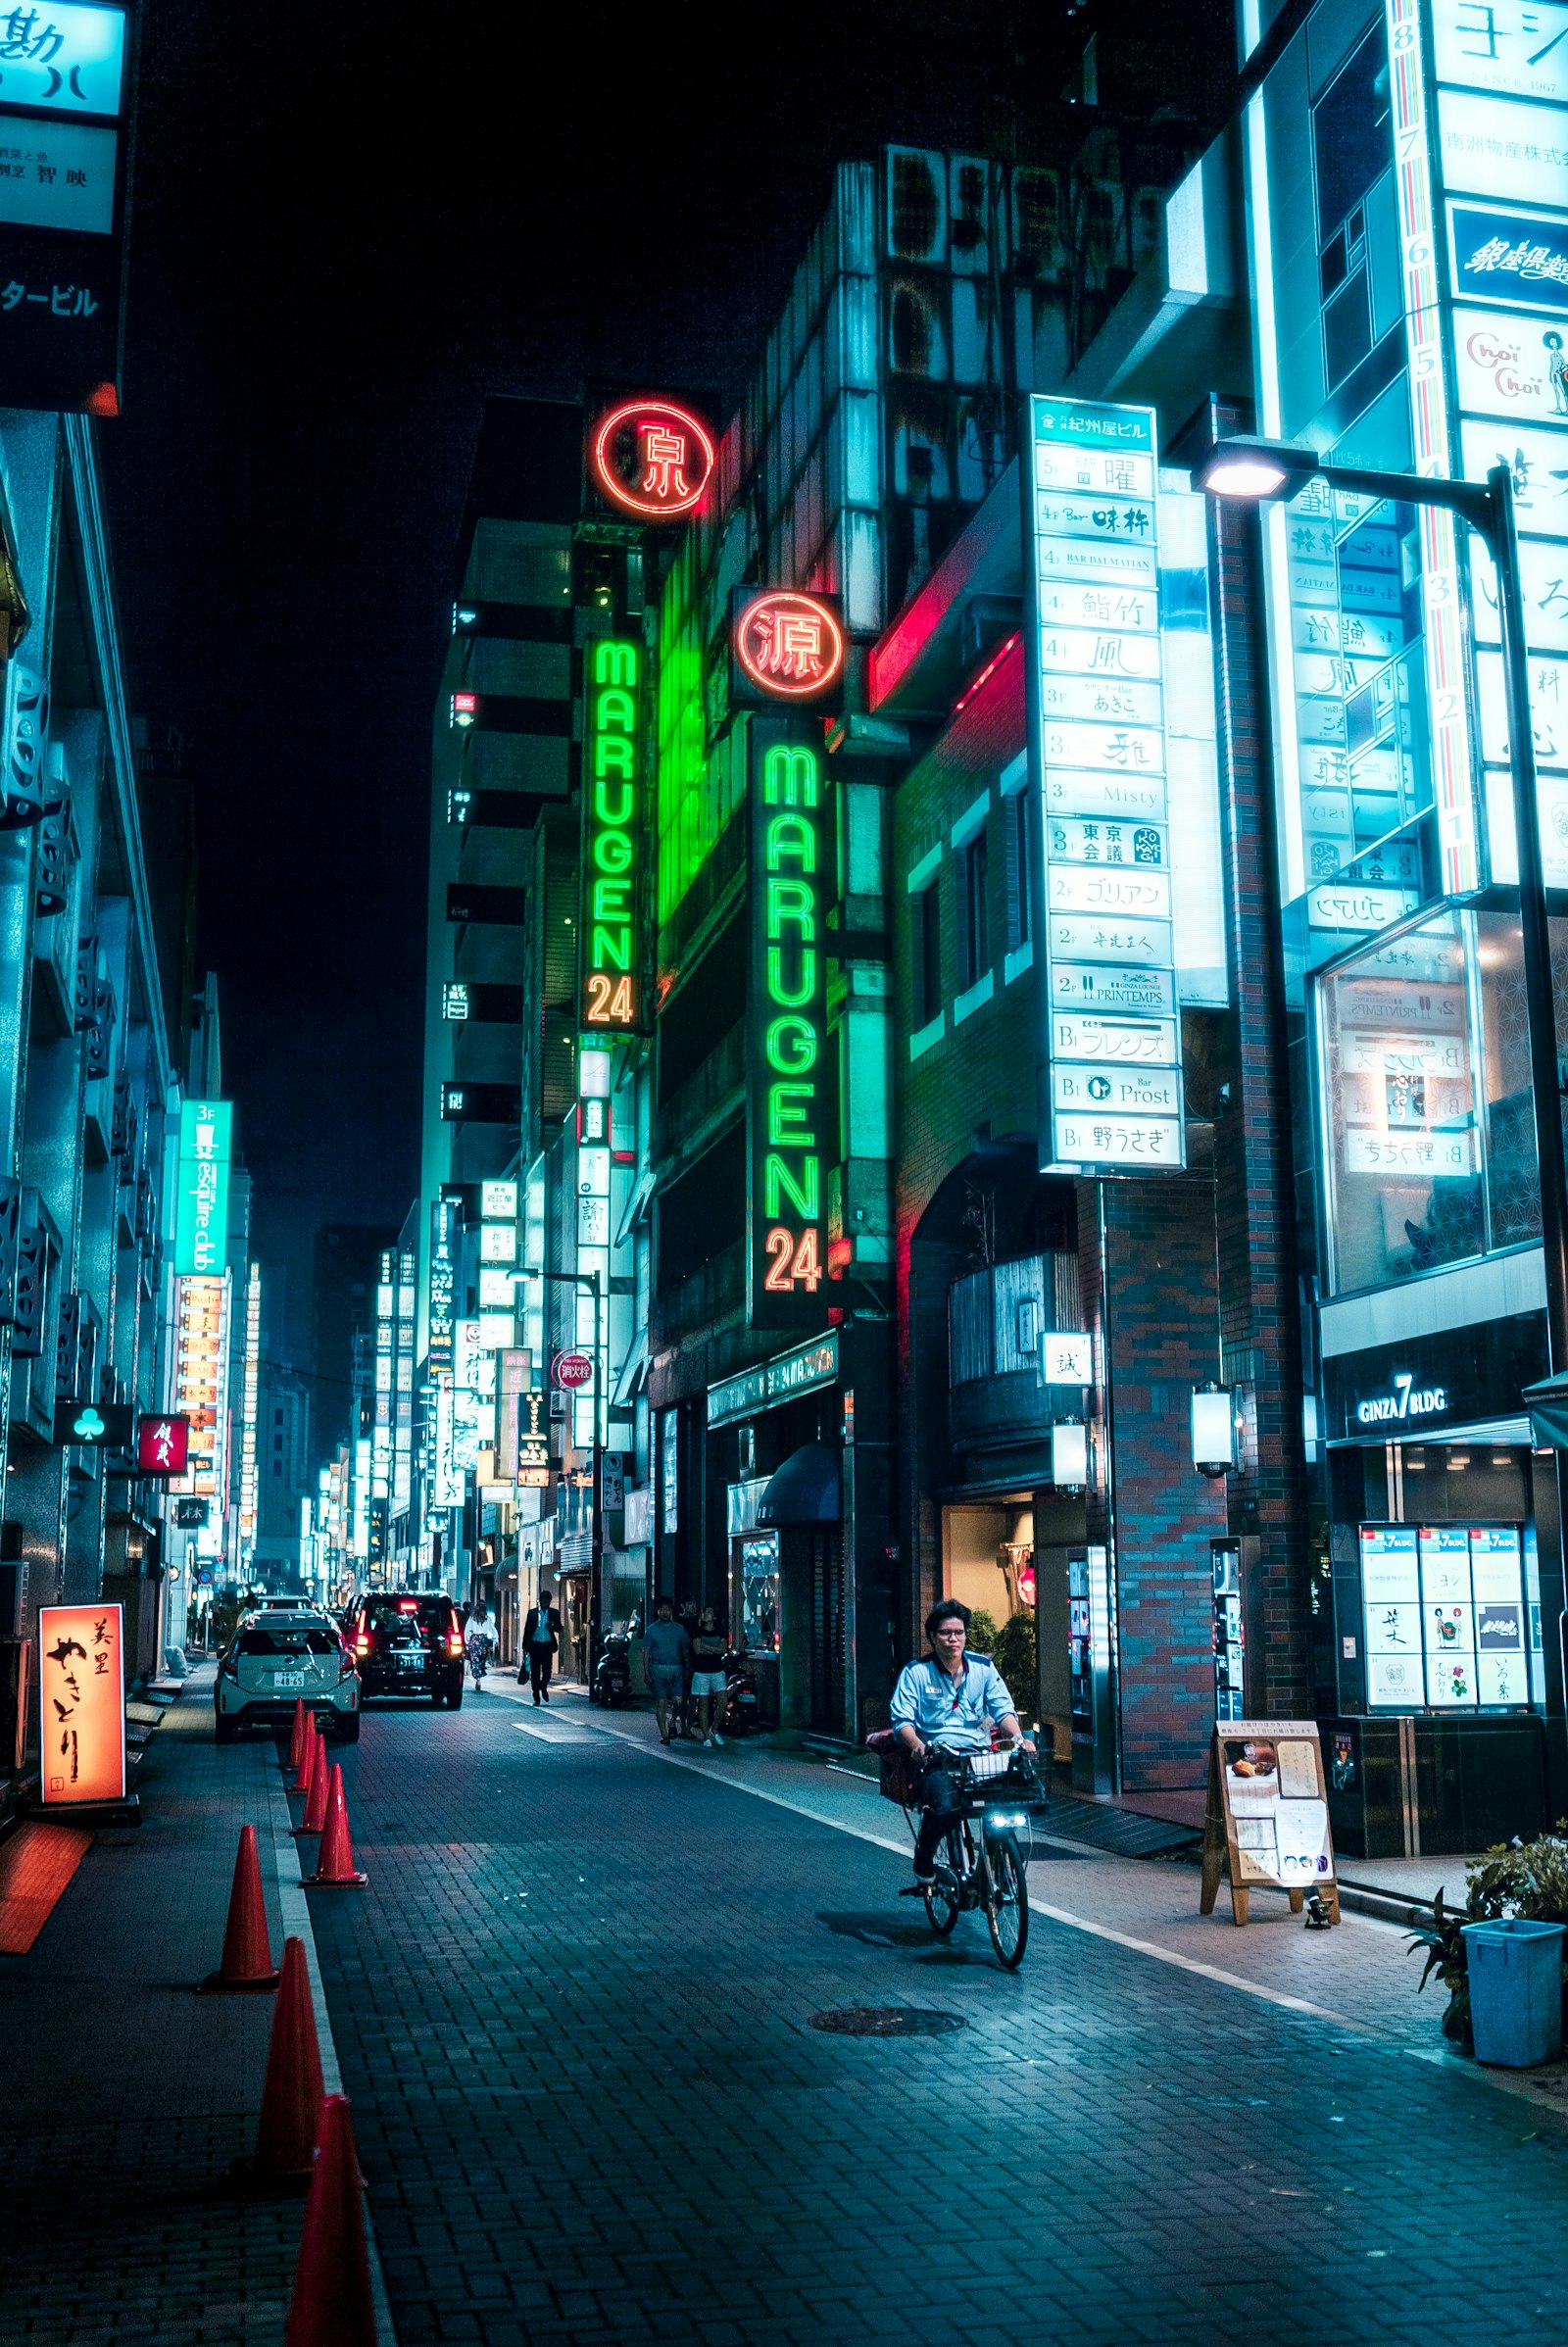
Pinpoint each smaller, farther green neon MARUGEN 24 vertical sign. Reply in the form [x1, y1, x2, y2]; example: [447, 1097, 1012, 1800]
[580, 636, 648, 1035]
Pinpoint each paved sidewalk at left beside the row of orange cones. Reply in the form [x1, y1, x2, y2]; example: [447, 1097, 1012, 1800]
[0, 1669, 384, 2347]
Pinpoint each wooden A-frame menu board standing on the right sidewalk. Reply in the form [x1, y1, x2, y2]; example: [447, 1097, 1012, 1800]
[1200, 1721, 1341, 1925]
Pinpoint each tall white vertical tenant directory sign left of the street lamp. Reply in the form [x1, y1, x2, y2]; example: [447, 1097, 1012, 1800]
[1023, 394, 1186, 1192]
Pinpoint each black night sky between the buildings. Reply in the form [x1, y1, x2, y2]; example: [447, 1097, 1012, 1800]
[101, 0, 1198, 1361]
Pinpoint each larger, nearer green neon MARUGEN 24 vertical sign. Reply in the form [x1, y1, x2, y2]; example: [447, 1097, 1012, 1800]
[747, 713, 833, 1329]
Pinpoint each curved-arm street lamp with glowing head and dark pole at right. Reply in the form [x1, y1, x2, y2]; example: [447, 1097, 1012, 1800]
[1193, 434, 1568, 1370]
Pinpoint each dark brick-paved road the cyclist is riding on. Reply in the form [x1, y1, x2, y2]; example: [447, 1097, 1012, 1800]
[313, 1697, 1568, 2347]
